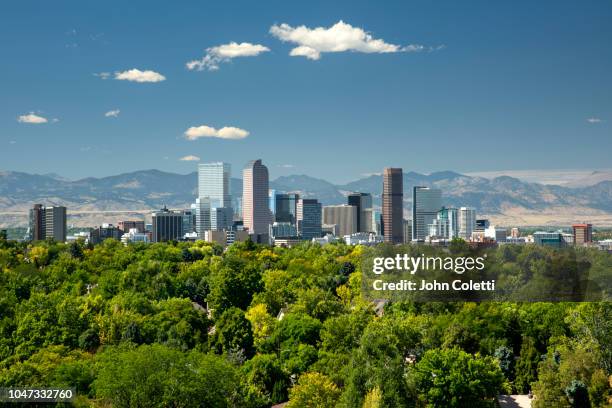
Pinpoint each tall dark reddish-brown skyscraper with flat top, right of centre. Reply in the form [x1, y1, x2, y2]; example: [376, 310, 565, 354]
[382, 167, 404, 244]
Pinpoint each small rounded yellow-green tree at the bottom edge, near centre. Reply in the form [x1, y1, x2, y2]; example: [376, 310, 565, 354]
[287, 372, 340, 408]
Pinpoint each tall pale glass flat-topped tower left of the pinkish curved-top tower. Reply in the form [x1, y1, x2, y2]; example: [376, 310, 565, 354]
[196, 162, 234, 233]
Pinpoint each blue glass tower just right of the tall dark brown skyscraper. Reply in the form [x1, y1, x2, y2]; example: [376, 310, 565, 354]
[412, 186, 442, 241]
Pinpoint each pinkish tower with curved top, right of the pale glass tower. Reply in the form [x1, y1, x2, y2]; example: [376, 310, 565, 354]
[242, 160, 271, 235]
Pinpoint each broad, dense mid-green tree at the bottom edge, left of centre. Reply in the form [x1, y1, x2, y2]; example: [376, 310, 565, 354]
[92, 344, 243, 408]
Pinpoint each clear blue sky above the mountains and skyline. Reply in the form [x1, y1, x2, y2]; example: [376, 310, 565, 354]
[0, 0, 612, 182]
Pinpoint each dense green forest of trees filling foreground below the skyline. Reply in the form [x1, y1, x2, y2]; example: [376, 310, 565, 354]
[0, 240, 612, 408]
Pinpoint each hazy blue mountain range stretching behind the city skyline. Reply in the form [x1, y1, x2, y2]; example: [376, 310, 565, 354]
[0, 170, 612, 225]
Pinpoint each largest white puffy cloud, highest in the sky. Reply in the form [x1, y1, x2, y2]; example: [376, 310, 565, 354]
[270, 20, 425, 60]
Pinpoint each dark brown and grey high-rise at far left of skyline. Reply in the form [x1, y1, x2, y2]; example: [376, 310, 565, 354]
[28, 204, 67, 242]
